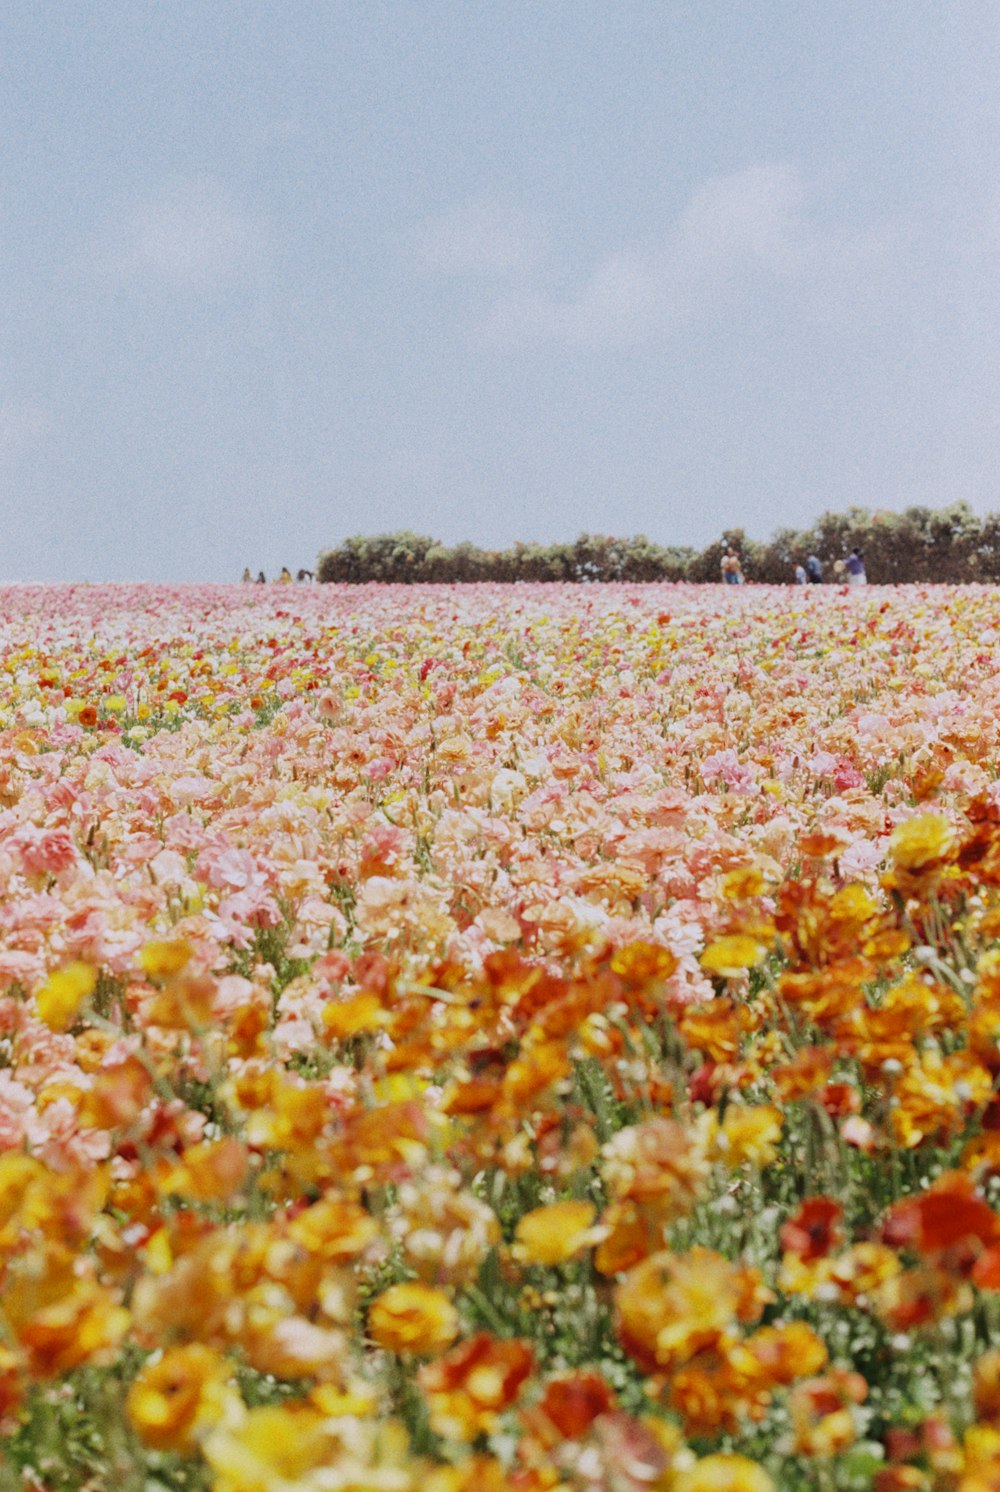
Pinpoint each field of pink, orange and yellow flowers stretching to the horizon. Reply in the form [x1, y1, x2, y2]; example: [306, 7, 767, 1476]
[0, 585, 1000, 1492]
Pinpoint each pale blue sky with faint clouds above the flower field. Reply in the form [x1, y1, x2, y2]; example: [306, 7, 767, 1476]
[0, 0, 1000, 582]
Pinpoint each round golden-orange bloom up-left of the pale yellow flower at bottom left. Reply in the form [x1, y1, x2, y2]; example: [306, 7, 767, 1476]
[125, 1343, 236, 1453]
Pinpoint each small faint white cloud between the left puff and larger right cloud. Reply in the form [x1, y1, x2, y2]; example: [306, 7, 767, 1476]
[416, 195, 542, 279]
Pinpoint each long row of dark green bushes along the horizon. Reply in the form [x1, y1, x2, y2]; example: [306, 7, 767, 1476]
[316, 503, 1000, 585]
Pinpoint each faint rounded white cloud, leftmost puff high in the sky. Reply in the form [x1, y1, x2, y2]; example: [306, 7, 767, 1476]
[101, 176, 267, 289]
